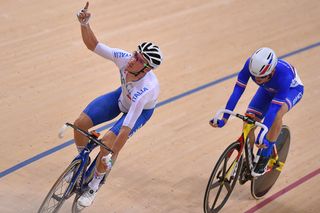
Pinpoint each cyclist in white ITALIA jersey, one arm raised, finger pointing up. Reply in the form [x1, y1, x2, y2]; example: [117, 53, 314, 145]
[74, 2, 163, 207]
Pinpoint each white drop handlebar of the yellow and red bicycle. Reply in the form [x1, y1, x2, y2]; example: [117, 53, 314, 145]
[213, 109, 268, 144]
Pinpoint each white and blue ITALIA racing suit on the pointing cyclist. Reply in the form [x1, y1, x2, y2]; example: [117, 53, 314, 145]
[84, 43, 160, 135]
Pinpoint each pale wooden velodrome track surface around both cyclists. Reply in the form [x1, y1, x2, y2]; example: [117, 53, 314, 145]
[0, 0, 320, 213]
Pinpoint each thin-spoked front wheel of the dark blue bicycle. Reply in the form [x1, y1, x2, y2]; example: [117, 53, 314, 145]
[38, 160, 81, 213]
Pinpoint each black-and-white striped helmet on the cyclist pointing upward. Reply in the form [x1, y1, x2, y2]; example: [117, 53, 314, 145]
[138, 42, 163, 69]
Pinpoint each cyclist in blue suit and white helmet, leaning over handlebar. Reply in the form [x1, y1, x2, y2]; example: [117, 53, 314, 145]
[210, 47, 304, 176]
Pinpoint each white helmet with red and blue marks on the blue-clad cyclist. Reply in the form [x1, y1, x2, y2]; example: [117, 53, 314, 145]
[249, 47, 278, 77]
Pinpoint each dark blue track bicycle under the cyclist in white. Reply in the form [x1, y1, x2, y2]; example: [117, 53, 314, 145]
[38, 123, 113, 213]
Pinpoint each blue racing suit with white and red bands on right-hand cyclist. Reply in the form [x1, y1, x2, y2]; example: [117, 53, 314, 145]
[223, 58, 304, 135]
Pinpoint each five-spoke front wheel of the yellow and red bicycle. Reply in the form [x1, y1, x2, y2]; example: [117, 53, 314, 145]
[203, 142, 242, 213]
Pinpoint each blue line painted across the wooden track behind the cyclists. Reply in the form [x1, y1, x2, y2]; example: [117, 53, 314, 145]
[0, 42, 320, 178]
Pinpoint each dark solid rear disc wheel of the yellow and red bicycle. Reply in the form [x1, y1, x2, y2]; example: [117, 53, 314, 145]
[251, 125, 290, 200]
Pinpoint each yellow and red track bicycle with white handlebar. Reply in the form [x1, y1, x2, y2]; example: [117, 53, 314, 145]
[203, 109, 290, 213]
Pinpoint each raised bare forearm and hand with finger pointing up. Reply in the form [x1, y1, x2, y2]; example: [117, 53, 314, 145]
[77, 2, 98, 51]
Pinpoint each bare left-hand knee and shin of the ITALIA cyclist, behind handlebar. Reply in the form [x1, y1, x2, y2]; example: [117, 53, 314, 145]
[74, 112, 93, 147]
